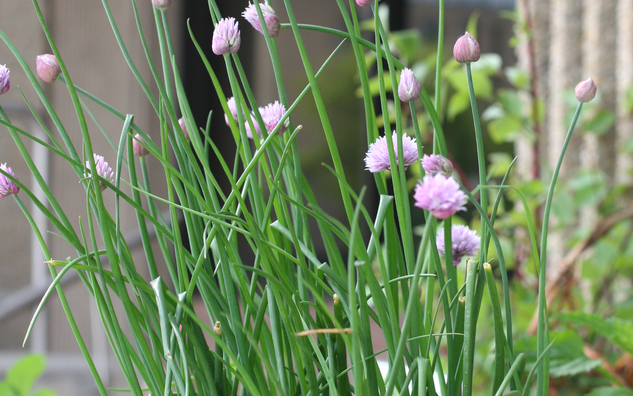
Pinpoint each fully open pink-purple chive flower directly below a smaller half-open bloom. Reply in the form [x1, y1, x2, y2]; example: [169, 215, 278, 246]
[413, 173, 467, 220]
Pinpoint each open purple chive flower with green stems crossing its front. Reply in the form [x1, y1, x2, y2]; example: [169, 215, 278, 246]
[365, 131, 418, 173]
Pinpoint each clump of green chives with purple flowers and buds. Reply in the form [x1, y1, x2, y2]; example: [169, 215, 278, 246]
[0, 0, 595, 396]
